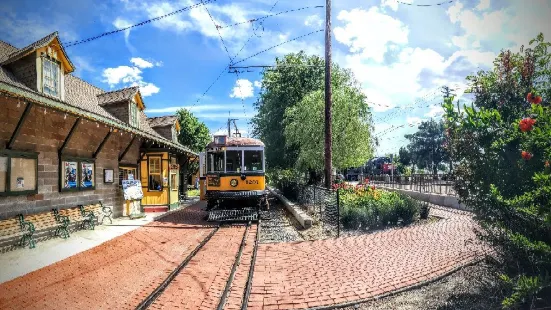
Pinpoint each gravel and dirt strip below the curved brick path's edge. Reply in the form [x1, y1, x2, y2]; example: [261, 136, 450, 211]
[342, 262, 503, 310]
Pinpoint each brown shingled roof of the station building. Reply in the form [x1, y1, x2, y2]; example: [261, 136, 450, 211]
[0, 33, 197, 155]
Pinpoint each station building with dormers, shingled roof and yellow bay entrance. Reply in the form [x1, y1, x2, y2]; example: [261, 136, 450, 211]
[0, 33, 197, 219]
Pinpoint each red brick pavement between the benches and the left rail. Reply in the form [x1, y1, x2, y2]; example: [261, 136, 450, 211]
[0, 205, 213, 309]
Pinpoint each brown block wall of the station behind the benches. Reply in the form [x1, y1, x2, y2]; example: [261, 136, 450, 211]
[0, 97, 140, 219]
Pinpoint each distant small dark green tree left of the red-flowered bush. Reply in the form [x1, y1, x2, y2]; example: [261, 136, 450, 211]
[405, 119, 449, 174]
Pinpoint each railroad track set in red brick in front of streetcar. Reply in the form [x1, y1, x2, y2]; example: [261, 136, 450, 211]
[136, 220, 260, 310]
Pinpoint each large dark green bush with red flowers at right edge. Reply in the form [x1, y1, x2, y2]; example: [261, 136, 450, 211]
[443, 34, 551, 307]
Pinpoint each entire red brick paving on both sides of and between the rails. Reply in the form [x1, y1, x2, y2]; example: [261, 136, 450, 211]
[0, 205, 488, 309]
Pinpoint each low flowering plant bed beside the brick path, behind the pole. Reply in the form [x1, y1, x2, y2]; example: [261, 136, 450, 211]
[340, 186, 421, 230]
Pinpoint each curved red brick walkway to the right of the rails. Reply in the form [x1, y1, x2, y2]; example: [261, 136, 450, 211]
[249, 209, 490, 309]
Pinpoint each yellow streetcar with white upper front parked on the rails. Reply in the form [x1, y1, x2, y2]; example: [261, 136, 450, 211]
[200, 136, 268, 221]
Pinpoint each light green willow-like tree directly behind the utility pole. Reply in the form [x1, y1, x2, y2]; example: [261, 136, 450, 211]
[284, 73, 373, 171]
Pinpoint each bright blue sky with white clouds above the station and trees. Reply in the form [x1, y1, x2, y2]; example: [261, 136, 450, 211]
[0, 0, 551, 155]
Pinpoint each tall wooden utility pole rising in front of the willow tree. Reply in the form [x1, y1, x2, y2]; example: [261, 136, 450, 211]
[325, 0, 333, 188]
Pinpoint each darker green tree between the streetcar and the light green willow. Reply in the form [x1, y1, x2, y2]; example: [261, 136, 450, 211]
[251, 52, 325, 168]
